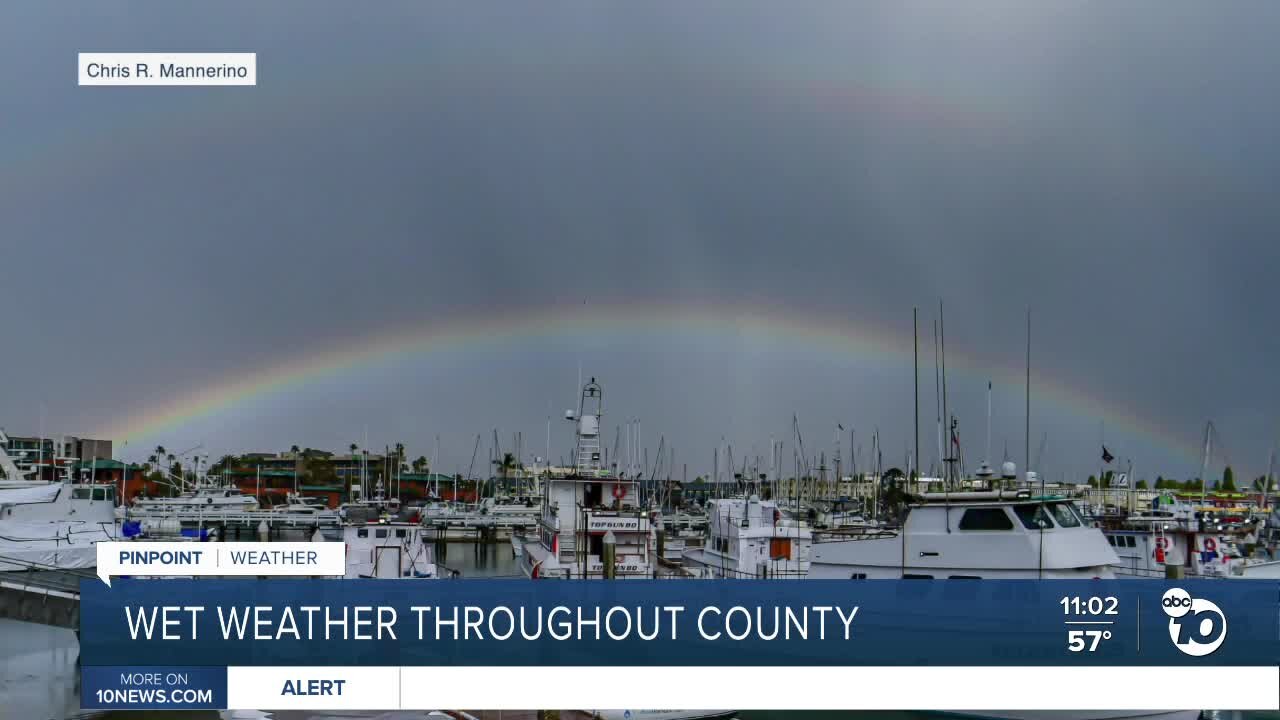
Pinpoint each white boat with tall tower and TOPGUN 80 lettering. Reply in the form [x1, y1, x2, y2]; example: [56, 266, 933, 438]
[520, 378, 653, 579]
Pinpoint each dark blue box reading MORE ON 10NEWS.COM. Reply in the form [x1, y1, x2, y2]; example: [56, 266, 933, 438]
[81, 666, 227, 710]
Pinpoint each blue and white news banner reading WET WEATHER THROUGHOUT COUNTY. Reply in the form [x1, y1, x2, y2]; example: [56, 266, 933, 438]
[81, 566, 1280, 710]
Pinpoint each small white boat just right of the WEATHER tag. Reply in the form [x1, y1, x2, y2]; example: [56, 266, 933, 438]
[342, 523, 439, 580]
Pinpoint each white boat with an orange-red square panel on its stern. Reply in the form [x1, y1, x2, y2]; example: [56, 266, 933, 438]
[682, 495, 813, 578]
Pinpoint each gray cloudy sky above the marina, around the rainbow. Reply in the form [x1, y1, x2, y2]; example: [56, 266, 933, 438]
[0, 0, 1280, 478]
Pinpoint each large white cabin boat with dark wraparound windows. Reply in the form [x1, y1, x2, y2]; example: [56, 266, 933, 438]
[809, 491, 1119, 580]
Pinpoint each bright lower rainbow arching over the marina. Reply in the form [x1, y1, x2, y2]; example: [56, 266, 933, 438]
[99, 301, 1199, 461]
